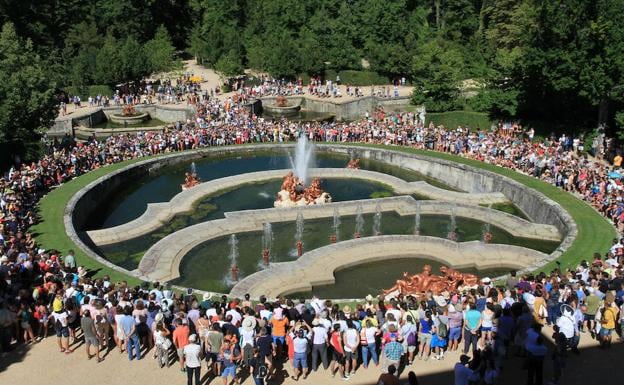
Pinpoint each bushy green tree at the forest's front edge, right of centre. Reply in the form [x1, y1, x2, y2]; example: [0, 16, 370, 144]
[412, 39, 463, 111]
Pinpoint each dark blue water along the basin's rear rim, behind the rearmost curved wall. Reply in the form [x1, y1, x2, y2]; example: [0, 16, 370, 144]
[82, 151, 448, 230]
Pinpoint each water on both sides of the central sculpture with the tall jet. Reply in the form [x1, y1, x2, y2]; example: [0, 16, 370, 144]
[99, 179, 394, 270]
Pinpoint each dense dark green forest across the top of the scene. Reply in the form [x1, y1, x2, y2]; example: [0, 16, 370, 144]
[0, 0, 624, 160]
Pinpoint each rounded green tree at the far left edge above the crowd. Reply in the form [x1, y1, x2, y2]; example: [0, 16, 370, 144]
[0, 23, 58, 162]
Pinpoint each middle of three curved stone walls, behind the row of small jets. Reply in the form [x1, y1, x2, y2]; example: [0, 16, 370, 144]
[137, 196, 560, 281]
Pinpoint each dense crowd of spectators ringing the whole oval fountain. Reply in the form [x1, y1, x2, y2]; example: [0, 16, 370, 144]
[0, 97, 624, 385]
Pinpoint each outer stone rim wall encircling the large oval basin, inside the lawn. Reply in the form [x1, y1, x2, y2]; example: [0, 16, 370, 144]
[65, 144, 577, 284]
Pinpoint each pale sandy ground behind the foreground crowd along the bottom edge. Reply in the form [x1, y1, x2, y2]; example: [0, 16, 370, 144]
[0, 326, 624, 385]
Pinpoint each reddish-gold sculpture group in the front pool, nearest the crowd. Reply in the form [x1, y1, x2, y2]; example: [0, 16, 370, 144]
[383, 265, 479, 296]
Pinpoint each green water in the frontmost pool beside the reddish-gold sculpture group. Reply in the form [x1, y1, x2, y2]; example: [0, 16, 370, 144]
[287, 256, 509, 299]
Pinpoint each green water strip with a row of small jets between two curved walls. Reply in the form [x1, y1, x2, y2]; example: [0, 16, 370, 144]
[168, 213, 558, 297]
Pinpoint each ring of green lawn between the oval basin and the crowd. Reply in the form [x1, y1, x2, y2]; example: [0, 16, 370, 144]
[31, 144, 616, 285]
